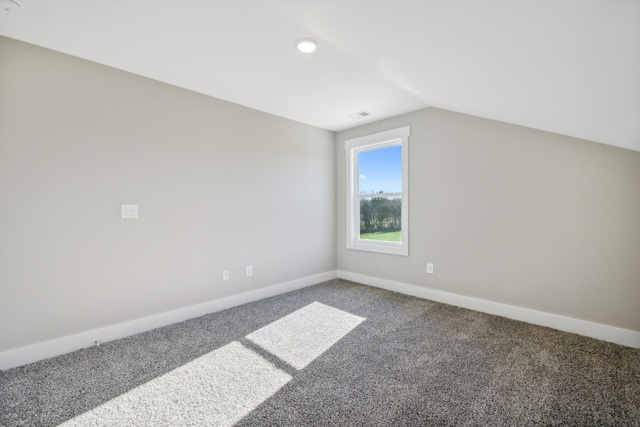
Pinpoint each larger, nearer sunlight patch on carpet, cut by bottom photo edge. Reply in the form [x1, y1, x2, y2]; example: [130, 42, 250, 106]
[61, 342, 291, 427]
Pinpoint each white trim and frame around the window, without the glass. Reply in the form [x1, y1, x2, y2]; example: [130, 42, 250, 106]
[345, 126, 411, 256]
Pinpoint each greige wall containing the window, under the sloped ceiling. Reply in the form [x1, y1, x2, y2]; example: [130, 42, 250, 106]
[336, 108, 640, 334]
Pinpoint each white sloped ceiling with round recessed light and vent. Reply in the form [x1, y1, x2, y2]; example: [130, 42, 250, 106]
[0, 0, 640, 151]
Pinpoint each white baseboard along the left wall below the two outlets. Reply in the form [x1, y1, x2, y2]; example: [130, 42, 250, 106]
[0, 270, 337, 370]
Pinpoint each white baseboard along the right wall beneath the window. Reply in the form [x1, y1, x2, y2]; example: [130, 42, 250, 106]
[338, 270, 640, 348]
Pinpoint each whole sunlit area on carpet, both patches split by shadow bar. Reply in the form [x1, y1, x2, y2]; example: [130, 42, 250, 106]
[60, 302, 365, 427]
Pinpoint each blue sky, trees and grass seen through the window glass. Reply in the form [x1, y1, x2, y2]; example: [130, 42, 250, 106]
[358, 145, 402, 242]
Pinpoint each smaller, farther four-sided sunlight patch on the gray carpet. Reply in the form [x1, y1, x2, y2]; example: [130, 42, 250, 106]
[247, 302, 365, 369]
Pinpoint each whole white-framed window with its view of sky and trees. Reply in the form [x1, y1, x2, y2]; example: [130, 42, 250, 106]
[345, 126, 410, 256]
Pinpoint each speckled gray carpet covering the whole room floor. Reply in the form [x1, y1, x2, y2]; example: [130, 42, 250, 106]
[0, 280, 640, 427]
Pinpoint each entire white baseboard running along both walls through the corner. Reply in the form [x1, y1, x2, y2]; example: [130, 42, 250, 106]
[0, 270, 640, 370]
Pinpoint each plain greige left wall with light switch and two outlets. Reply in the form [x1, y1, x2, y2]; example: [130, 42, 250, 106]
[0, 38, 336, 352]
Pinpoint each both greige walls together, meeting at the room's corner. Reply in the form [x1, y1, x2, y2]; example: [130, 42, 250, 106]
[0, 38, 640, 366]
